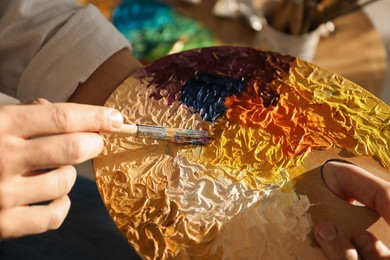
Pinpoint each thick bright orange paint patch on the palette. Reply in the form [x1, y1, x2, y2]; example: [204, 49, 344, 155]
[225, 76, 357, 157]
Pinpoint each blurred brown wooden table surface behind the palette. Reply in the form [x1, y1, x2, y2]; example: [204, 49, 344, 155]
[167, 0, 387, 96]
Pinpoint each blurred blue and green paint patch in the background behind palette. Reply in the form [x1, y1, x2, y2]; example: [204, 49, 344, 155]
[112, 0, 215, 63]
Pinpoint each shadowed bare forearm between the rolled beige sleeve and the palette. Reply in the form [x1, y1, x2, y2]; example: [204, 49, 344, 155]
[68, 49, 142, 105]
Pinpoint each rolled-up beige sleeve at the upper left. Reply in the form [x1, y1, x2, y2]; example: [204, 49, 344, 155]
[0, 0, 130, 102]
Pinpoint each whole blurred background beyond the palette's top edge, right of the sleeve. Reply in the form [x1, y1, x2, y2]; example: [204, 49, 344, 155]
[78, 0, 390, 104]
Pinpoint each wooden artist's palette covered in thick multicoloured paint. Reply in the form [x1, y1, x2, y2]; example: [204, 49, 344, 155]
[94, 46, 390, 259]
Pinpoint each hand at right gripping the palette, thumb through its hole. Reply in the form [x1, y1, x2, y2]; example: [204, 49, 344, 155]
[314, 161, 390, 259]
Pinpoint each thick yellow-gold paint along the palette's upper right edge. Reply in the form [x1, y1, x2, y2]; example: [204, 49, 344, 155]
[288, 59, 390, 169]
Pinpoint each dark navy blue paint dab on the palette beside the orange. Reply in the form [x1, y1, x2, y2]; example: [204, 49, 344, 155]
[181, 73, 245, 122]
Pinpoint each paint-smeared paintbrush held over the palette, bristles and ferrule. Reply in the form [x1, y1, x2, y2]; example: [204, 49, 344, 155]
[108, 124, 209, 145]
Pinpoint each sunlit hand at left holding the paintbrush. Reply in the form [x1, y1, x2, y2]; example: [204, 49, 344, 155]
[0, 100, 123, 240]
